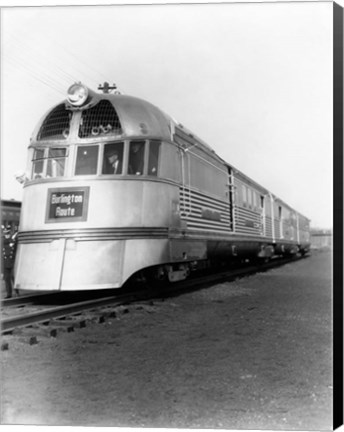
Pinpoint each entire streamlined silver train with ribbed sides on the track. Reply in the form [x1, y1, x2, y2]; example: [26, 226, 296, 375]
[14, 82, 310, 291]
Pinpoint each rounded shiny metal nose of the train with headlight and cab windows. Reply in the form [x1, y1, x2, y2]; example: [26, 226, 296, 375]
[15, 83, 183, 291]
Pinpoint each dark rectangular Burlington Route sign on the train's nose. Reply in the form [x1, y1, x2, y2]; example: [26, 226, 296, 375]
[46, 187, 89, 222]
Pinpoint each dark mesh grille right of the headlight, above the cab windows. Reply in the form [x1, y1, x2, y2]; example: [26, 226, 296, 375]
[79, 100, 122, 138]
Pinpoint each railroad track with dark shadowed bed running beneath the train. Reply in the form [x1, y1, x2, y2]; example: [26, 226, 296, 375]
[1, 253, 306, 349]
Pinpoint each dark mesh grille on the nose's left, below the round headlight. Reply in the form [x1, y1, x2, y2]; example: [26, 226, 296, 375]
[37, 103, 72, 140]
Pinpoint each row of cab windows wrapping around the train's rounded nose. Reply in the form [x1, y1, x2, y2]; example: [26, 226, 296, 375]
[31, 141, 161, 179]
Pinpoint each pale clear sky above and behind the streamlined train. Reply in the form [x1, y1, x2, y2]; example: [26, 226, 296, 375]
[1, 1, 333, 228]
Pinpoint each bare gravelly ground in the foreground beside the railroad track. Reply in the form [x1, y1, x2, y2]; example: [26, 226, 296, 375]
[1, 252, 332, 430]
